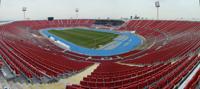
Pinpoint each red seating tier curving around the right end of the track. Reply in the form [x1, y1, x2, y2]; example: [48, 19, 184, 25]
[119, 20, 200, 64]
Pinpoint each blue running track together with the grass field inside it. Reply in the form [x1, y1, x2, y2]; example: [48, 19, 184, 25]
[40, 28, 142, 56]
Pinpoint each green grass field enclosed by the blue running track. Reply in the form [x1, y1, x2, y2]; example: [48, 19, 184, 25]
[48, 28, 118, 48]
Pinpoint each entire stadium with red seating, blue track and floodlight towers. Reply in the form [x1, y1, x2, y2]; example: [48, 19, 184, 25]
[0, 0, 200, 89]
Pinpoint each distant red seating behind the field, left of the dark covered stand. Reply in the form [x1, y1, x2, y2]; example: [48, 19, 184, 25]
[13, 19, 94, 30]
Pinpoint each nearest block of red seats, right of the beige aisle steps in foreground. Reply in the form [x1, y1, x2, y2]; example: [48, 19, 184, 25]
[67, 56, 200, 89]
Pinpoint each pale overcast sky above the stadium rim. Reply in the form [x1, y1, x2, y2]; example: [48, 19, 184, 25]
[0, 0, 200, 20]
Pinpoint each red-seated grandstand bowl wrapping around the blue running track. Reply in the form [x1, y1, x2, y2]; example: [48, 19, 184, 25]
[0, 19, 200, 89]
